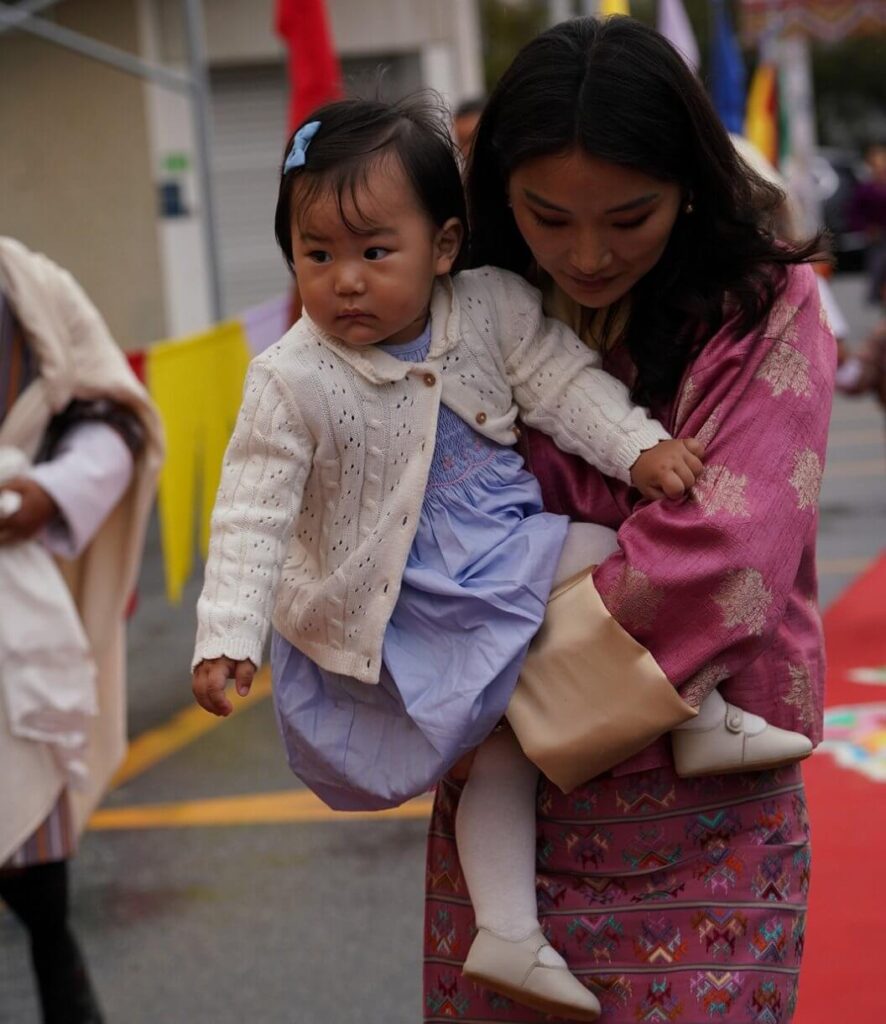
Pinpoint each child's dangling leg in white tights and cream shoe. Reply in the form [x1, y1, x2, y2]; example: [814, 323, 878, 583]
[456, 729, 600, 1021]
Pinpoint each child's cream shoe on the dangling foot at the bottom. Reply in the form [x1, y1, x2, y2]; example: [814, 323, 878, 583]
[464, 928, 600, 1021]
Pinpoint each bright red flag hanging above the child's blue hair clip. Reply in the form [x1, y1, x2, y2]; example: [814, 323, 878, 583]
[276, 0, 341, 131]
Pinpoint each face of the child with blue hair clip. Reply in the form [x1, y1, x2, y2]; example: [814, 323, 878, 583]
[292, 160, 462, 347]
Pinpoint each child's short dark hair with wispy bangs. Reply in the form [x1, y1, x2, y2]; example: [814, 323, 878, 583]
[273, 95, 467, 273]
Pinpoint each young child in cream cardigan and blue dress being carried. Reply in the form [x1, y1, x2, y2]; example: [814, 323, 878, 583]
[194, 100, 802, 1020]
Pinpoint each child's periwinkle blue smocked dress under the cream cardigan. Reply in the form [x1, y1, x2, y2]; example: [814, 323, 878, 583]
[271, 327, 568, 811]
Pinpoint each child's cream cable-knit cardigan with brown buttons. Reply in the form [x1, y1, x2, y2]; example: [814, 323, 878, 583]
[194, 267, 669, 683]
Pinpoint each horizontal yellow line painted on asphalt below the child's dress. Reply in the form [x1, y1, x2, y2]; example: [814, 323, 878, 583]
[89, 790, 433, 830]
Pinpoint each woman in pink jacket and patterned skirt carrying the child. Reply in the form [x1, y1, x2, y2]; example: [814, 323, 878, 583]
[425, 18, 835, 1024]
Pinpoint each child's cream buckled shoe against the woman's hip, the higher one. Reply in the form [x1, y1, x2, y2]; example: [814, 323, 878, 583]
[671, 703, 812, 778]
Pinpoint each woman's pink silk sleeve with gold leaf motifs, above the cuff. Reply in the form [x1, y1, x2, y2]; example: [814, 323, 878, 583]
[594, 272, 836, 685]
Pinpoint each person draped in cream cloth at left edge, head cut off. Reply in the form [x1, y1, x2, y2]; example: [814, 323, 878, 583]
[0, 238, 162, 1024]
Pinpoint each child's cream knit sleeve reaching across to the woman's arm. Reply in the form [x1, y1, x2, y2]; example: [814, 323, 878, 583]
[487, 271, 671, 483]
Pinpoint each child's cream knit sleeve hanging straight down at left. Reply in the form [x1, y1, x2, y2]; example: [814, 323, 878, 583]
[192, 359, 313, 668]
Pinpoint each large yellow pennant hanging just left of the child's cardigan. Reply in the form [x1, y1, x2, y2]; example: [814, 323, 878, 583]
[146, 322, 250, 603]
